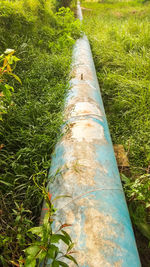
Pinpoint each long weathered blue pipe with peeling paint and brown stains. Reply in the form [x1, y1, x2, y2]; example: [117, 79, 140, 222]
[41, 2, 141, 267]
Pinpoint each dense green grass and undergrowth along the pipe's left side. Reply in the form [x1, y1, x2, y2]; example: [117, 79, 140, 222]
[0, 0, 80, 266]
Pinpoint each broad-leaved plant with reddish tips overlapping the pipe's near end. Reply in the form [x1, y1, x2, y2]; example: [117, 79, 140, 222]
[24, 177, 78, 267]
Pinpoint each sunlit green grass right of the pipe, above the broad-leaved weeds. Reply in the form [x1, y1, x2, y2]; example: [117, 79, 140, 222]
[84, 0, 150, 172]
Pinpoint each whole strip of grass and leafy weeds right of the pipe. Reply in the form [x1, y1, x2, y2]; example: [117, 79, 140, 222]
[82, 1, 150, 267]
